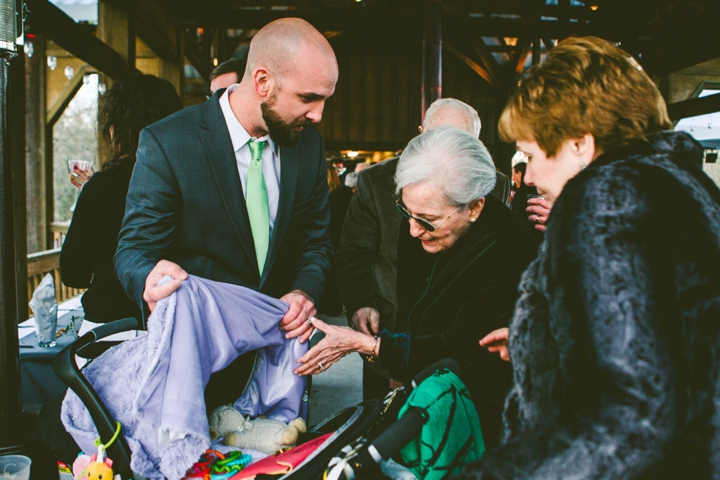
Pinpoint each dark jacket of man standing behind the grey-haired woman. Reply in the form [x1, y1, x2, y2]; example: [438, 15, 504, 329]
[335, 157, 510, 330]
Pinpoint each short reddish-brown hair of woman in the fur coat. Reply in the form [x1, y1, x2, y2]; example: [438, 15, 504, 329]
[499, 37, 672, 157]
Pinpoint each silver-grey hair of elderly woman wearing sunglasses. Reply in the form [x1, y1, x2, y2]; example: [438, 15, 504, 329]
[395, 125, 496, 206]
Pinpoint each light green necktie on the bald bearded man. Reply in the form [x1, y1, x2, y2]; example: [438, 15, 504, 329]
[245, 140, 270, 276]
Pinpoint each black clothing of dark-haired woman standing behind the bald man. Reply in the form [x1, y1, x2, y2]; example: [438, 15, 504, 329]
[60, 165, 140, 323]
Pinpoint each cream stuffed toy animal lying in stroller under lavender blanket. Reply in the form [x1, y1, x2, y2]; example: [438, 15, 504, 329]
[210, 405, 307, 454]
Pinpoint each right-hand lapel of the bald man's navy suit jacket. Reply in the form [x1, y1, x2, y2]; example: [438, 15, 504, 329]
[260, 142, 298, 287]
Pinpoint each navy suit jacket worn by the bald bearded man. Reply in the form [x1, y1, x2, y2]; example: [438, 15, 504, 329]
[115, 90, 332, 316]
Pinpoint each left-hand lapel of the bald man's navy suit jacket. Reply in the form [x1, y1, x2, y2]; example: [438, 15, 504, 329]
[200, 95, 258, 276]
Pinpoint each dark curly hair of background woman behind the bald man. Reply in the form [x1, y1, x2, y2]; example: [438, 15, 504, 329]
[98, 75, 182, 169]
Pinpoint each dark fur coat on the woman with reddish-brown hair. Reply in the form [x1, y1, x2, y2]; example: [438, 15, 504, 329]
[458, 132, 720, 479]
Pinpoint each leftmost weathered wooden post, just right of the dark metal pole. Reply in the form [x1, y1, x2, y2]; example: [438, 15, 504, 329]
[25, 35, 50, 253]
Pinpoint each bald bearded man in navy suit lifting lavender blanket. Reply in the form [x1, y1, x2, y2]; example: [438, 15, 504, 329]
[115, 18, 338, 408]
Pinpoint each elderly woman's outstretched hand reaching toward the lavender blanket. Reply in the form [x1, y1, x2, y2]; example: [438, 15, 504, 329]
[294, 318, 373, 375]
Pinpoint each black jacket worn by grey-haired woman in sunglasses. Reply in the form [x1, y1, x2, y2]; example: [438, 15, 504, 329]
[379, 196, 536, 443]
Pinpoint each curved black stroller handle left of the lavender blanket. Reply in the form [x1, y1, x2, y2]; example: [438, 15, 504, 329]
[53, 318, 142, 478]
